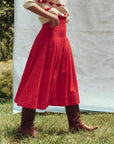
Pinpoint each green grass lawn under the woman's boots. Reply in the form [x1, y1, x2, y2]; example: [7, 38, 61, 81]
[0, 98, 114, 144]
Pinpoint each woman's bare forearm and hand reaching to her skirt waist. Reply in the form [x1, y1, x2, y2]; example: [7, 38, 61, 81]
[27, 5, 59, 28]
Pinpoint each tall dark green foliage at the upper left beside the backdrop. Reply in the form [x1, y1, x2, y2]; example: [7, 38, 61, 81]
[0, 0, 14, 61]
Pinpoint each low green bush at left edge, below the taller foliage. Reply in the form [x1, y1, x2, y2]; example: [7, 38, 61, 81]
[0, 70, 13, 98]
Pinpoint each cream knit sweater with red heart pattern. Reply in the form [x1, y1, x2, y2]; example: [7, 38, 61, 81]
[23, 0, 69, 24]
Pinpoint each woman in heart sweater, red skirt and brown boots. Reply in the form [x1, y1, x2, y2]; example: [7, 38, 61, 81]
[14, 0, 98, 137]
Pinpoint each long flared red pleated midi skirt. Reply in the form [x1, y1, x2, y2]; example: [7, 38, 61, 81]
[14, 17, 80, 110]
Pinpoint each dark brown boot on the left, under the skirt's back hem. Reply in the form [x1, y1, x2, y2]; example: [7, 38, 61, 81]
[20, 107, 41, 138]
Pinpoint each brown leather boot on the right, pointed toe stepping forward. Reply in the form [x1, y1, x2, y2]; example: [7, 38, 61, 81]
[65, 105, 98, 132]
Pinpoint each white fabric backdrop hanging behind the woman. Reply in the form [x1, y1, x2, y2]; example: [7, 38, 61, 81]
[13, 0, 114, 113]
